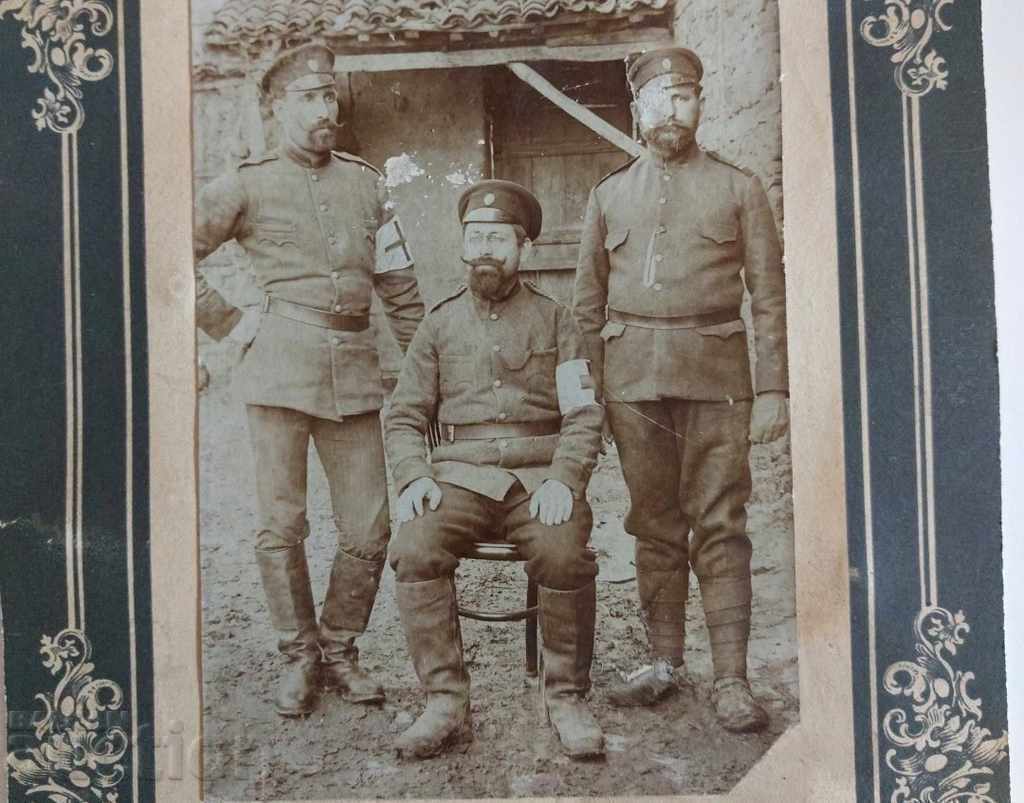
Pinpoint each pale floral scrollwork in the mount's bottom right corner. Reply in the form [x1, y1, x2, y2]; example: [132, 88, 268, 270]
[882, 607, 1007, 803]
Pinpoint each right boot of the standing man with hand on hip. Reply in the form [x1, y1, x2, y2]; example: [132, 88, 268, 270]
[318, 548, 384, 703]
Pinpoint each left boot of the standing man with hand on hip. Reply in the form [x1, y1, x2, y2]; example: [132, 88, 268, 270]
[256, 543, 321, 717]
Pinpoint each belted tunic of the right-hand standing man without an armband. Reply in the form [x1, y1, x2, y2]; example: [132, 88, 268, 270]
[574, 146, 787, 402]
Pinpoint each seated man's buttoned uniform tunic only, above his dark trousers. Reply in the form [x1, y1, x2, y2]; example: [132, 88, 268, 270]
[384, 283, 604, 500]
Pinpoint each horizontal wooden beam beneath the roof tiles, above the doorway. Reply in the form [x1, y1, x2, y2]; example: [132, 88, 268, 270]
[334, 32, 672, 73]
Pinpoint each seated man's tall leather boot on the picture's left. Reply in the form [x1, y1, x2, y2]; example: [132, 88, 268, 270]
[394, 577, 473, 758]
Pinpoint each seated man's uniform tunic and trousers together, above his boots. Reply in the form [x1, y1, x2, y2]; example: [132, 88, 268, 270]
[384, 283, 604, 590]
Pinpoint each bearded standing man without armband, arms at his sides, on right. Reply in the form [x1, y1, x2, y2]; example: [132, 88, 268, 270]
[574, 48, 788, 731]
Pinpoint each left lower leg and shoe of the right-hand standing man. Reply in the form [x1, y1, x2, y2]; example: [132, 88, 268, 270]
[607, 557, 690, 706]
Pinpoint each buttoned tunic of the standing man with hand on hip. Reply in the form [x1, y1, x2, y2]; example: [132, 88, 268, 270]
[196, 146, 423, 420]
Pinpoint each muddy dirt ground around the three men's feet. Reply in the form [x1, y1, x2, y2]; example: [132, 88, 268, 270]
[200, 344, 799, 800]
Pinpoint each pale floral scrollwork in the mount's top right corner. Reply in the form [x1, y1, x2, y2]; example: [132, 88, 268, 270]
[860, 0, 953, 96]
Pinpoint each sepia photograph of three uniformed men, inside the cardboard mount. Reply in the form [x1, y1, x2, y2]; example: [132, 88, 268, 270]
[191, 0, 799, 800]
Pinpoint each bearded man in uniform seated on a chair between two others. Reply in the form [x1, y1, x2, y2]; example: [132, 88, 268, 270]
[385, 180, 604, 758]
